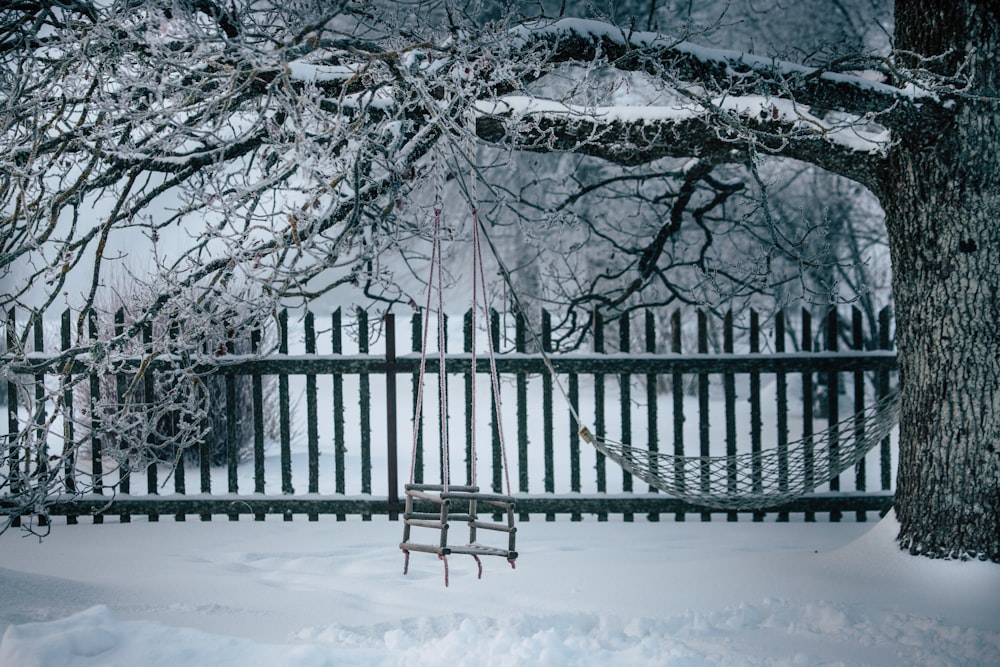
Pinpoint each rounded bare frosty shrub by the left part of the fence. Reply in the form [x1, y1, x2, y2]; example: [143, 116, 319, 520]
[75, 281, 277, 470]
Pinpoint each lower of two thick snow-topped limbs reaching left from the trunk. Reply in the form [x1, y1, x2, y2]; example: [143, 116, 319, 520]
[476, 96, 890, 182]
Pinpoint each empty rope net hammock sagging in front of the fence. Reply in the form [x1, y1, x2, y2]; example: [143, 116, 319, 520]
[580, 393, 899, 510]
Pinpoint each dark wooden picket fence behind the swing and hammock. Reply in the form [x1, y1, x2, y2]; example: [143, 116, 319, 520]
[0, 309, 896, 523]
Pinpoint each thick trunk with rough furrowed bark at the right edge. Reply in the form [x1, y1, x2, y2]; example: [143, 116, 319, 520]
[880, 0, 1000, 562]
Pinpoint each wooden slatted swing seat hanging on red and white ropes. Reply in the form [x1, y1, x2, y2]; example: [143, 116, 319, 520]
[399, 207, 517, 586]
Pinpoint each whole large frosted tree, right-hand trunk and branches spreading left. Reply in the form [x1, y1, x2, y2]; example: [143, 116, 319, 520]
[0, 0, 1000, 561]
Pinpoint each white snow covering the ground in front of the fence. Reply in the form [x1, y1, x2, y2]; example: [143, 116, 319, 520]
[0, 514, 1000, 667]
